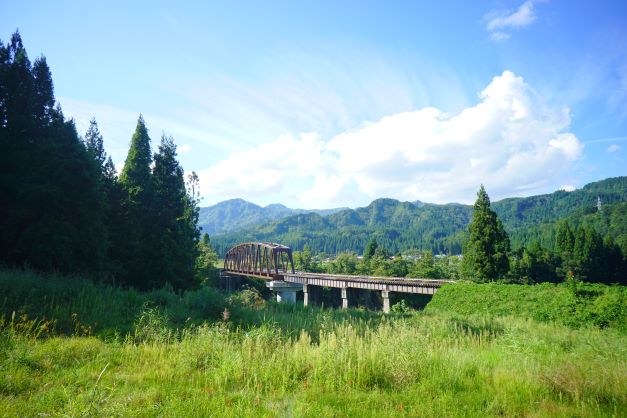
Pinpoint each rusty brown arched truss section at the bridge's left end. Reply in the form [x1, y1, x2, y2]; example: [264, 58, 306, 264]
[224, 242, 294, 279]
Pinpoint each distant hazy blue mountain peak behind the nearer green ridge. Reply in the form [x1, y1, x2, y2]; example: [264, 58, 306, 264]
[198, 199, 345, 235]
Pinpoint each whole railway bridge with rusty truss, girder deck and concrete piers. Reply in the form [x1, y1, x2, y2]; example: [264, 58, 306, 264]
[222, 242, 452, 312]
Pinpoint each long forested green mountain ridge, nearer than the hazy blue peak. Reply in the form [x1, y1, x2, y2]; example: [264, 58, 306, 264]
[212, 177, 627, 254]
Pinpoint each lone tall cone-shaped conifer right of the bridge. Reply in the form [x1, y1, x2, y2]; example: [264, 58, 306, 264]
[463, 185, 509, 282]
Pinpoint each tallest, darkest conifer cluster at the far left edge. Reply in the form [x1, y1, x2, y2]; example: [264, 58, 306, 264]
[0, 32, 104, 272]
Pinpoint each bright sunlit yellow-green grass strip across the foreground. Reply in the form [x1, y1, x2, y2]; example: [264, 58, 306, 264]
[0, 311, 627, 417]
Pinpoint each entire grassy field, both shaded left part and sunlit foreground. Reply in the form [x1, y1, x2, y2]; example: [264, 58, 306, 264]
[0, 271, 627, 417]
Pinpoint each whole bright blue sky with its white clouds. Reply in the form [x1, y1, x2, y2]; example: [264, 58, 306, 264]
[0, 0, 627, 209]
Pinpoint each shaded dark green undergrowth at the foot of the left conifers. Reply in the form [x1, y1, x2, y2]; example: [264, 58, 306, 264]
[0, 270, 226, 337]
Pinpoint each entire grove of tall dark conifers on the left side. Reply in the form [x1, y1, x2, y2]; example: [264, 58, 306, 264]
[0, 32, 216, 289]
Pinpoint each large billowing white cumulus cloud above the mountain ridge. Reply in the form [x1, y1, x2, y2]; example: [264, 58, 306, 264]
[199, 71, 583, 207]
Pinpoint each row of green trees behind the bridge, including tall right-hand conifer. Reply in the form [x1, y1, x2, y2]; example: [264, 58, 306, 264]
[294, 186, 627, 284]
